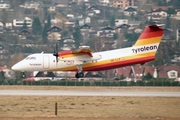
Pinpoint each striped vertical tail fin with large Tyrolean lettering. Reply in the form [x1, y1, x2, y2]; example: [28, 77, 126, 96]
[132, 25, 164, 56]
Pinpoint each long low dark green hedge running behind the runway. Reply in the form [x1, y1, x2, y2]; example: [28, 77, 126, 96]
[0, 79, 180, 86]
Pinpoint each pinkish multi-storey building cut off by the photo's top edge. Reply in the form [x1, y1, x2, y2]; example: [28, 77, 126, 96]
[112, 0, 135, 9]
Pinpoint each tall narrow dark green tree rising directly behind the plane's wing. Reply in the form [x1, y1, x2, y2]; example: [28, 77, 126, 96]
[73, 21, 82, 47]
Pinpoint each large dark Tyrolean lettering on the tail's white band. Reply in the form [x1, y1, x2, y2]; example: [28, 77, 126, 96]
[132, 45, 158, 53]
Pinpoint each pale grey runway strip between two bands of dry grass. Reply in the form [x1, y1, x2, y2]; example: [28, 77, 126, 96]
[0, 90, 180, 97]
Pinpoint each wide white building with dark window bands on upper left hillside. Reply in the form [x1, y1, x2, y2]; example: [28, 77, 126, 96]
[13, 17, 33, 27]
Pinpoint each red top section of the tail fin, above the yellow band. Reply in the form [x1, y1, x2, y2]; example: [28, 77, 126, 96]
[138, 26, 164, 40]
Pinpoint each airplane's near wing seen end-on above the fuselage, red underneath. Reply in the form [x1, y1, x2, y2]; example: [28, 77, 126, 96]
[72, 46, 93, 57]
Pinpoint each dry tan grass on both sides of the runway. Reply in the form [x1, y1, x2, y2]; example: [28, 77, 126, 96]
[0, 86, 180, 120]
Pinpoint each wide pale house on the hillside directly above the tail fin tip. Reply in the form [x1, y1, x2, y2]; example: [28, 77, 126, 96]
[146, 9, 168, 20]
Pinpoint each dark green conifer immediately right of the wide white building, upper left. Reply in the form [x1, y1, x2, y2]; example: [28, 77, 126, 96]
[32, 17, 42, 35]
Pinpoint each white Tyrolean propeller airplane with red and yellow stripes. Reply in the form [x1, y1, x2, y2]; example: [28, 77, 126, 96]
[12, 25, 164, 78]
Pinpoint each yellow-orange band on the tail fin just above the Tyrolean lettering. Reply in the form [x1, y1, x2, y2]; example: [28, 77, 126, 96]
[134, 36, 162, 46]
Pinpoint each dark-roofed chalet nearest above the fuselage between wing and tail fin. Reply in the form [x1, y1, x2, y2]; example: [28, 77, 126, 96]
[97, 27, 115, 38]
